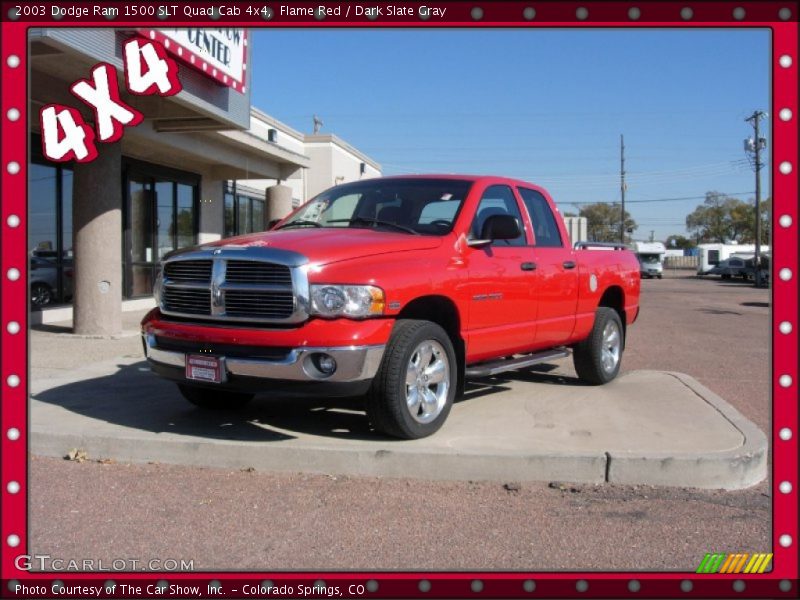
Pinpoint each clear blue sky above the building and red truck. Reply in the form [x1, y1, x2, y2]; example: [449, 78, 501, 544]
[250, 29, 770, 240]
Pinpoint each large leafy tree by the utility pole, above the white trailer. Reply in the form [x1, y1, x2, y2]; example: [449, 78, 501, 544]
[686, 192, 771, 244]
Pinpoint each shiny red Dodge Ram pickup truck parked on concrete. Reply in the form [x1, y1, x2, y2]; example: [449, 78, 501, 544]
[142, 175, 639, 439]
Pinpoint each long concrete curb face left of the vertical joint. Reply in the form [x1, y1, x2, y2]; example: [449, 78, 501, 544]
[30, 431, 606, 483]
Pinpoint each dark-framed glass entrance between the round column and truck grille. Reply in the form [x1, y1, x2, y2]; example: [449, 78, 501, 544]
[123, 159, 200, 298]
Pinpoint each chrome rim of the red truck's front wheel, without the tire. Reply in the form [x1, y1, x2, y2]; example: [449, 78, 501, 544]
[406, 340, 450, 423]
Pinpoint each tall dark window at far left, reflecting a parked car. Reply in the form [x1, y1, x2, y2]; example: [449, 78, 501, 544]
[28, 136, 73, 309]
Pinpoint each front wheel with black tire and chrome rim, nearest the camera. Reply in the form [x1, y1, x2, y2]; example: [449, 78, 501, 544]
[367, 319, 458, 440]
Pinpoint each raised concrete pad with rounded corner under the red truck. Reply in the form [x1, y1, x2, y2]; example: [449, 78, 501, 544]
[30, 355, 767, 489]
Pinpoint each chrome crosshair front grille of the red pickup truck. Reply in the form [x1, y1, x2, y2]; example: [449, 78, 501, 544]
[157, 247, 308, 323]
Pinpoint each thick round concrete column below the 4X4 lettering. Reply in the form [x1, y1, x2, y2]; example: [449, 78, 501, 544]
[72, 142, 122, 335]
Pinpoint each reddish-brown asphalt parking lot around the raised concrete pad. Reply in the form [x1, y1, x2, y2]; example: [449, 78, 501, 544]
[29, 272, 771, 570]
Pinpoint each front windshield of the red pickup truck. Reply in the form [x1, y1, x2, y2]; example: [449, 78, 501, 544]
[278, 178, 472, 235]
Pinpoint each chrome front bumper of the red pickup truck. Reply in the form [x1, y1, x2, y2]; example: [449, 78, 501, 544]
[142, 334, 386, 383]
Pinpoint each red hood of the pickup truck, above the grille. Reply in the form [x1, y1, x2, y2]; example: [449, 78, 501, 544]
[203, 227, 443, 265]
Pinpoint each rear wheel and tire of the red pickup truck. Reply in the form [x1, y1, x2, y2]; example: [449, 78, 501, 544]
[572, 306, 624, 385]
